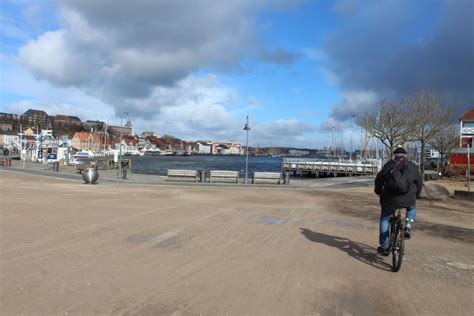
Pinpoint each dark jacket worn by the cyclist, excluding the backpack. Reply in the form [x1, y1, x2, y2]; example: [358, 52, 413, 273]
[374, 157, 423, 213]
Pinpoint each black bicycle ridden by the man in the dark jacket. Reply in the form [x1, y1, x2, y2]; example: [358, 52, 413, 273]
[389, 209, 405, 272]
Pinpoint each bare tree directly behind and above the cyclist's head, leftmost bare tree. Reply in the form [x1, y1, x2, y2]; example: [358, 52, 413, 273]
[356, 99, 410, 157]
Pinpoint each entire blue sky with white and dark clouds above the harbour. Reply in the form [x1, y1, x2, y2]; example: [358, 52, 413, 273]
[0, 0, 474, 148]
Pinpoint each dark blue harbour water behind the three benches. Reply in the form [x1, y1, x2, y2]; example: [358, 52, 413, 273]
[127, 156, 282, 176]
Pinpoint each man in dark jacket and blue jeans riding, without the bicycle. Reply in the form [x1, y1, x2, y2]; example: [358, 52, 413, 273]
[374, 147, 423, 256]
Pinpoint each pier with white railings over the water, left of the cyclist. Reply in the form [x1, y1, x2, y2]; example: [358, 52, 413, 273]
[282, 158, 382, 177]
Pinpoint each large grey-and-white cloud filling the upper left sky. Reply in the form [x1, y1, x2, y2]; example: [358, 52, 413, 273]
[15, 0, 263, 114]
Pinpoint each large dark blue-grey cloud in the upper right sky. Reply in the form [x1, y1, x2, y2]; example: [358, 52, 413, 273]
[325, 0, 474, 120]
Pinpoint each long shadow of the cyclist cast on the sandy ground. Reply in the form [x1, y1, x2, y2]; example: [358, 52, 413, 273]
[300, 228, 391, 271]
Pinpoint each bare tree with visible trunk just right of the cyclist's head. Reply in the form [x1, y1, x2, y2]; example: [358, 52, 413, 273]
[406, 89, 453, 178]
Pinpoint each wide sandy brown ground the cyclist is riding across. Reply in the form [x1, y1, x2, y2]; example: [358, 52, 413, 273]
[0, 170, 474, 315]
